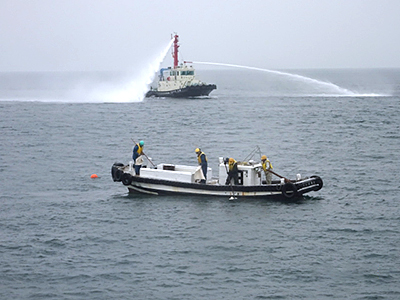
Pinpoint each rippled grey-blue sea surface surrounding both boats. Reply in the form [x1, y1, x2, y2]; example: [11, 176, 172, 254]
[0, 68, 400, 300]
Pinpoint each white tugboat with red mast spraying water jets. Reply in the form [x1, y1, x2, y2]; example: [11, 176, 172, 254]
[146, 34, 217, 98]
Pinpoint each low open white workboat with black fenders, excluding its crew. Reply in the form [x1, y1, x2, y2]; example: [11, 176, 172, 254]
[111, 157, 323, 200]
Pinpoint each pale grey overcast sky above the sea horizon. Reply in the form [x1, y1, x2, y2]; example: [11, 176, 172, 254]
[0, 0, 400, 72]
